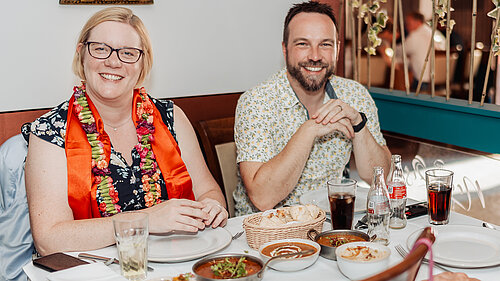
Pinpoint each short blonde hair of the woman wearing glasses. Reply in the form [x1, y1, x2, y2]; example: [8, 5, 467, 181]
[73, 7, 153, 86]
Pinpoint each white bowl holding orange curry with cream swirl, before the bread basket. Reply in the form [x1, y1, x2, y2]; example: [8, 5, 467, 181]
[259, 238, 321, 271]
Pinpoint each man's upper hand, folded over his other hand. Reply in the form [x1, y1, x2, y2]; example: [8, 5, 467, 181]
[311, 99, 363, 125]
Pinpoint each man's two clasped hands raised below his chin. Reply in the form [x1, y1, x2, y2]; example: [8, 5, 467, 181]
[309, 99, 363, 139]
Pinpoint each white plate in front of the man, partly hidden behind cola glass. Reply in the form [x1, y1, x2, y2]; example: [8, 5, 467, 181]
[299, 186, 369, 214]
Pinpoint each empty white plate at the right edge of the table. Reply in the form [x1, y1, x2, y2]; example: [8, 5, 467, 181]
[406, 225, 500, 268]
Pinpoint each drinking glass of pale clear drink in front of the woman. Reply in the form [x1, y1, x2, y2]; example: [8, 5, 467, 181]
[113, 211, 149, 280]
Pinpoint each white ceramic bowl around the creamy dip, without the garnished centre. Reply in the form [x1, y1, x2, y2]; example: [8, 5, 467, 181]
[335, 242, 391, 280]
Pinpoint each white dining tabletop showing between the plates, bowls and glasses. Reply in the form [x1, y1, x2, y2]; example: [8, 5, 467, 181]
[23, 212, 500, 281]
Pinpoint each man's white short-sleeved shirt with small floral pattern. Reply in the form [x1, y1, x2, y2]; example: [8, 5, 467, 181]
[233, 68, 386, 215]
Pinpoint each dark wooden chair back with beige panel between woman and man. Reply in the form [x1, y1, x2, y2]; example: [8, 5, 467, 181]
[194, 117, 238, 217]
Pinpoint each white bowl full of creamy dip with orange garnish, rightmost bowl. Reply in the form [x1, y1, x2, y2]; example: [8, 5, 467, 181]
[335, 242, 391, 280]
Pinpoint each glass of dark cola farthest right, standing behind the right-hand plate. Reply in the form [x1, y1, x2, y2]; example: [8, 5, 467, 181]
[425, 169, 453, 225]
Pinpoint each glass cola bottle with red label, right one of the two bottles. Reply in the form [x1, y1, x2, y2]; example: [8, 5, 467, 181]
[387, 154, 406, 228]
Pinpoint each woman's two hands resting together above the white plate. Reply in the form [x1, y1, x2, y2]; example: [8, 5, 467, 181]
[144, 198, 228, 233]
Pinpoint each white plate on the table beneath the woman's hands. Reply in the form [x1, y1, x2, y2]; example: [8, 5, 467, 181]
[148, 227, 231, 262]
